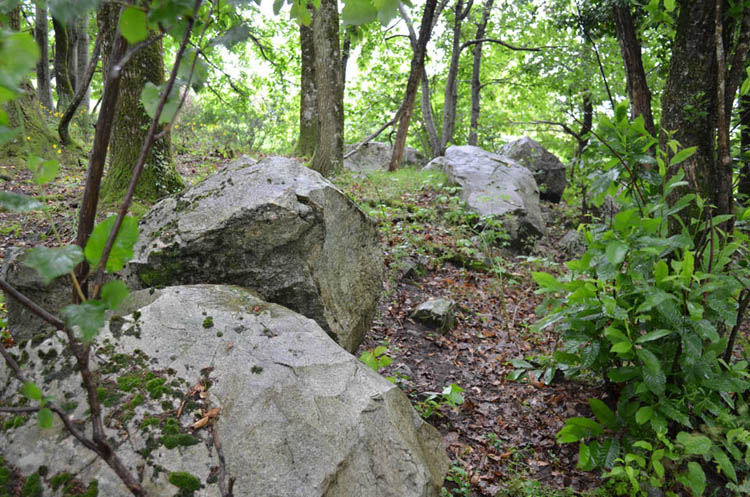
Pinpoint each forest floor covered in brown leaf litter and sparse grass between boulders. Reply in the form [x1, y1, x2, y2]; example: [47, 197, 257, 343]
[0, 152, 606, 497]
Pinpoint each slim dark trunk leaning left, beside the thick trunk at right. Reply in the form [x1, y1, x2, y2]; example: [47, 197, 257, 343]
[612, 1, 656, 136]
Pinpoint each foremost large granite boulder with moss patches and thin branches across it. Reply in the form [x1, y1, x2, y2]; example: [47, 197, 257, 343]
[0, 285, 449, 497]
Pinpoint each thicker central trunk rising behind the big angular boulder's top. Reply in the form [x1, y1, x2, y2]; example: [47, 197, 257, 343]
[312, 0, 344, 176]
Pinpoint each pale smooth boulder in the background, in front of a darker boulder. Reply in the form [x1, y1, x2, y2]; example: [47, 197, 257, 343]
[426, 145, 545, 249]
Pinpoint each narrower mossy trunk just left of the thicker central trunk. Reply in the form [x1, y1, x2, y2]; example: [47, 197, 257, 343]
[295, 17, 318, 157]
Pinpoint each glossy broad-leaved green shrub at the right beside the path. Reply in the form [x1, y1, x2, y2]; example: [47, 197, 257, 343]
[534, 109, 750, 495]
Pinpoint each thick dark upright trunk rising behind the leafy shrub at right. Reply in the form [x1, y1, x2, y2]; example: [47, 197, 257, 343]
[659, 0, 718, 215]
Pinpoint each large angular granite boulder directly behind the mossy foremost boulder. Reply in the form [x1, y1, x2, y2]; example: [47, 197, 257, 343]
[126, 157, 383, 352]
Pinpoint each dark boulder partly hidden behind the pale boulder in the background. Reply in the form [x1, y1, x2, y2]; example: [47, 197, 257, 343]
[498, 137, 567, 203]
